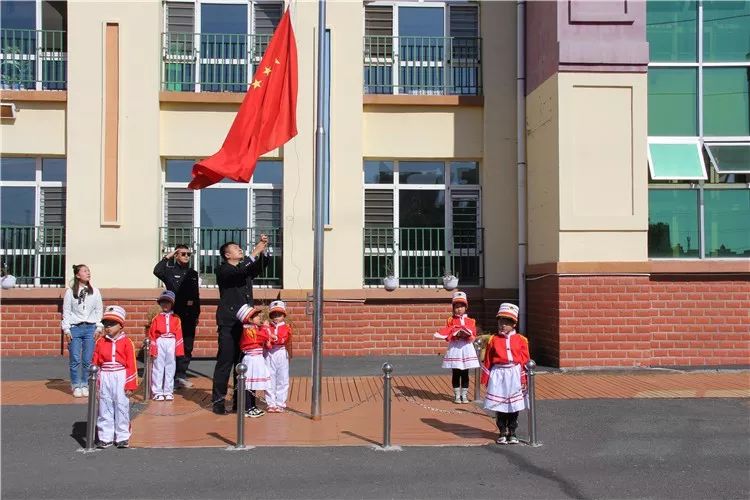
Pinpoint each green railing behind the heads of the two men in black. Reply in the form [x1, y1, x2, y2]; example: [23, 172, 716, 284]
[159, 226, 283, 288]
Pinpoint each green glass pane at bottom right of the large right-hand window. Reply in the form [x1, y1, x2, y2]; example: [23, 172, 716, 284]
[703, 189, 750, 258]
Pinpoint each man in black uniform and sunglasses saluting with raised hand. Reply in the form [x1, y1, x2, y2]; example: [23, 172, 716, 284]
[154, 245, 201, 387]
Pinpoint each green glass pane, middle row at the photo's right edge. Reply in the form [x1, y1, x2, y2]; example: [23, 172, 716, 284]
[703, 67, 750, 136]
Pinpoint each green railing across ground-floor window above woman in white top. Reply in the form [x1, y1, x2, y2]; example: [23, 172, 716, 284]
[0, 226, 65, 286]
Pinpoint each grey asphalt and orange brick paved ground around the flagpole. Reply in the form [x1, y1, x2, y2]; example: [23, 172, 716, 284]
[0, 357, 750, 499]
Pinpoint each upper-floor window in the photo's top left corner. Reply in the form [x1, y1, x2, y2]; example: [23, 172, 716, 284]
[0, 0, 68, 90]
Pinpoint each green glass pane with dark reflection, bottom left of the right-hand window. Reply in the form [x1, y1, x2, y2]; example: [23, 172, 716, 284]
[648, 189, 700, 258]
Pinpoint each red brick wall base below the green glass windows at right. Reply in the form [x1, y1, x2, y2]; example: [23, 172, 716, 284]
[527, 274, 750, 367]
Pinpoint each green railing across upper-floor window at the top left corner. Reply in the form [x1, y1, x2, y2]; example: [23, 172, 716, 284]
[0, 29, 68, 90]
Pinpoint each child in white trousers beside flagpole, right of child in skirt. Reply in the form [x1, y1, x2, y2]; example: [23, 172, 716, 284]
[266, 300, 292, 413]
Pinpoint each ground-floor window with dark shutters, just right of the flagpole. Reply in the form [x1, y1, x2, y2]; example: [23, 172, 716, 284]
[363, 160, 482, 286]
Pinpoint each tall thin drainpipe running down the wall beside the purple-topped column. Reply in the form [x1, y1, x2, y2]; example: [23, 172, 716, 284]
[516, 0, 528, 332]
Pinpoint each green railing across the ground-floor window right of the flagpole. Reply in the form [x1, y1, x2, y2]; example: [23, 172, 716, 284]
[364, 226, 484, 287]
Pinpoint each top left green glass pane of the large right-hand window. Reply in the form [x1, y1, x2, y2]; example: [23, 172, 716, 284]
[646, 0, 698, 62]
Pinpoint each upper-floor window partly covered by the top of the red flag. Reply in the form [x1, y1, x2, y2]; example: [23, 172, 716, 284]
[163, 0, 284, 92]
